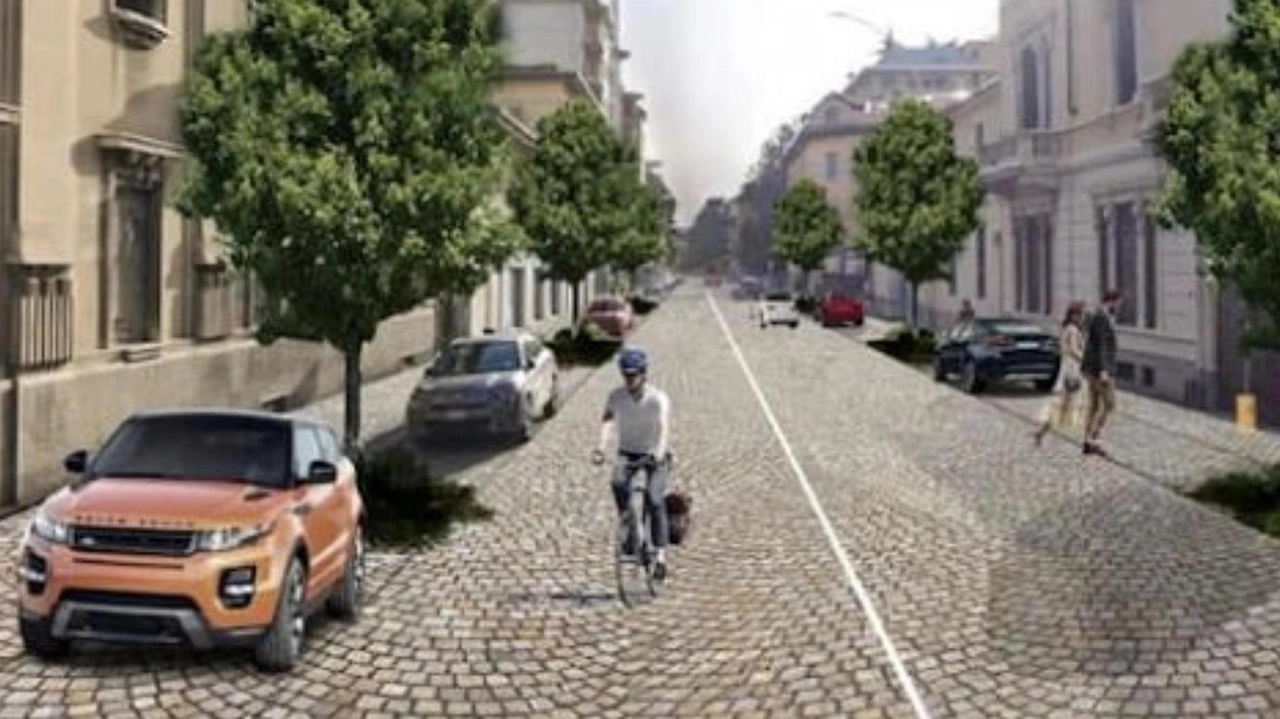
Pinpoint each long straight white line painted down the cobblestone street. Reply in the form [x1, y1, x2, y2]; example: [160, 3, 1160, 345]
[707, 292, 931, 719]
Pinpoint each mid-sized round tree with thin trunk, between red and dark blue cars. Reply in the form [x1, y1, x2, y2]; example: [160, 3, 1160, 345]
[854, 100, 983, 326]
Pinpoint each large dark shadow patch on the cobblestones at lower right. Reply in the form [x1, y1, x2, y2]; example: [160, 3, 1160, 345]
[986, 482, 1280, 682]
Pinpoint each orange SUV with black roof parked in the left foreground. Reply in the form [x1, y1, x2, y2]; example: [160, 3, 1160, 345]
[18, 409, 365, 670]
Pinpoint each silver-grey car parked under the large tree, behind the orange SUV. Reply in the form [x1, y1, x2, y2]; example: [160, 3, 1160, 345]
[406, 331, 559, 441]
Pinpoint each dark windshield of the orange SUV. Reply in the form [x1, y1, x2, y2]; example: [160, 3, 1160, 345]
[92, 415, 291, 487]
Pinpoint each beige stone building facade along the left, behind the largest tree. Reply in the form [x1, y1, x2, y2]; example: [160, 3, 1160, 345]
[0, 0, 609, 505]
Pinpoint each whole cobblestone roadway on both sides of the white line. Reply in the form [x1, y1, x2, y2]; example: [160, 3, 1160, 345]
[0, 288, 1280, 718]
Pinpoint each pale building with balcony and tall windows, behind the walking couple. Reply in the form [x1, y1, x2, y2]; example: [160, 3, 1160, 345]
[922, 0, 1280, 414]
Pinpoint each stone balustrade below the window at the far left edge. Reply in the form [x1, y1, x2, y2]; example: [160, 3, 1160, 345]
[9, 265, 74, 370]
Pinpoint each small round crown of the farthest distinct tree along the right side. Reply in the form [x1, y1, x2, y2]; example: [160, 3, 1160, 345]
[773, 178, 845, 273]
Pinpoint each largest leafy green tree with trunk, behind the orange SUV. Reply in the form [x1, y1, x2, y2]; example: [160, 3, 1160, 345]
[179, 0, 511, 448]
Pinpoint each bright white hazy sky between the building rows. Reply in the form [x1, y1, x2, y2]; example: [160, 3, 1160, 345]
[621, 0, 1000, 224]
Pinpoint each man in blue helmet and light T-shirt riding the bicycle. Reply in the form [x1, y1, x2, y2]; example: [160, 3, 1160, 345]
[591, 348, 671, 580]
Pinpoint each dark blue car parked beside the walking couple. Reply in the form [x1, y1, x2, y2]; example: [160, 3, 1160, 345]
[933, 317, 1061, 394]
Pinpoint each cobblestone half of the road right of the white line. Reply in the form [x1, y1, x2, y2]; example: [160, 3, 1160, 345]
[737, 294, 1280, 718]
